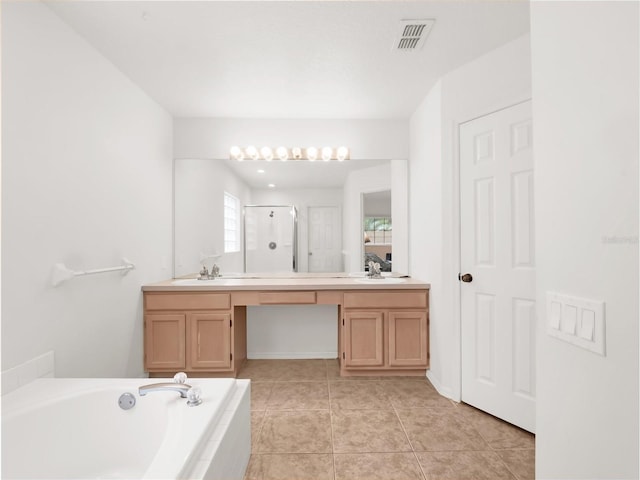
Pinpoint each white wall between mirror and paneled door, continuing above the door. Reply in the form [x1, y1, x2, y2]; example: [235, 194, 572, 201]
[409, 35, 531, 399]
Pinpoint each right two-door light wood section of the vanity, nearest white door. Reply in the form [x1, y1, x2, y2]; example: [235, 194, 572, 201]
[342, 291, 429, 374]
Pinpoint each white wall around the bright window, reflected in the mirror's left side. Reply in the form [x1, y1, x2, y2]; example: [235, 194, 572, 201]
[174, 159, 252, 276]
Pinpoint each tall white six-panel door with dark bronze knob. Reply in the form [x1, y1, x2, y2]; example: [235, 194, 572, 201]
[460, 102, 536, 432]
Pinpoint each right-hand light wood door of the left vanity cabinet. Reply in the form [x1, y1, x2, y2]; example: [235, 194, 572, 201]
[187, 313, 232, 370]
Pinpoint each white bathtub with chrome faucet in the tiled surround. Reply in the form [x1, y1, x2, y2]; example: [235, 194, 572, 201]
[2, 378, 251, 480]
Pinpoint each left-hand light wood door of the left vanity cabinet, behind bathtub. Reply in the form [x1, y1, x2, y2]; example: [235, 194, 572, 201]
[144, 313, 185, 370]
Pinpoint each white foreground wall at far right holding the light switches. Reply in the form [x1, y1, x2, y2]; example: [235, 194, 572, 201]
[531, 2, 639, 479]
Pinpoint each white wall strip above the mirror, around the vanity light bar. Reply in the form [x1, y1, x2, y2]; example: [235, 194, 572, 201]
[174, 118, 408, 160]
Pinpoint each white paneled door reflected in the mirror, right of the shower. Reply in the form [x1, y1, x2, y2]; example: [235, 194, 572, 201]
[309, 207, 343, 272]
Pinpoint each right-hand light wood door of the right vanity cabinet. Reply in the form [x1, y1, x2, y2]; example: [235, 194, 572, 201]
[388, 311, 428, 367]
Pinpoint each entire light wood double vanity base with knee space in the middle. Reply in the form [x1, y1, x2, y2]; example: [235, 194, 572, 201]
[143, 279, 429, 377]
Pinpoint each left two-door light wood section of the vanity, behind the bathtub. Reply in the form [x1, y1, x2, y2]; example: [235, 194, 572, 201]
[144, 292, 246, 376]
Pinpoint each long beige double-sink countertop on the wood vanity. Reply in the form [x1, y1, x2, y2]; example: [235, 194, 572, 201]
[142, 273, 429, 292]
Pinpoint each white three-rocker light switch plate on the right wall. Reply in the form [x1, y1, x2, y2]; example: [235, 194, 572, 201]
[547, 292, 606, 356]
